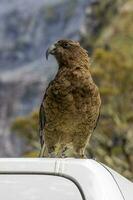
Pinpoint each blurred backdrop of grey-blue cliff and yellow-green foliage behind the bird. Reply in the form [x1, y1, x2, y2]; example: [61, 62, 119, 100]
[0, 0, 133, 180]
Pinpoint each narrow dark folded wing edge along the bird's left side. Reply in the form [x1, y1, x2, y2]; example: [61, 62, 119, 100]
[39, 102, 46, 147]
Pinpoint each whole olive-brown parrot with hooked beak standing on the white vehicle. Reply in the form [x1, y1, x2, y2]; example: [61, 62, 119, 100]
[40, 40, 101, 158]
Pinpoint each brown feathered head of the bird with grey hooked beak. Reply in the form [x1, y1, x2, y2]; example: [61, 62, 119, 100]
[46, 39, 89, 67]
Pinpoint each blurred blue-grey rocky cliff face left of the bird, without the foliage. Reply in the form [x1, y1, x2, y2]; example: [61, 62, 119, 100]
[0, 0, 89, 157]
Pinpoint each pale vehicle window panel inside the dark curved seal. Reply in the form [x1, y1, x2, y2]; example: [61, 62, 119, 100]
[0, 174, 82, 200]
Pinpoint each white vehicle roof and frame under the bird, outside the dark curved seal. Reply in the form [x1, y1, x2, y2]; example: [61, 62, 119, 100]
[0, 158, 133, 200]
